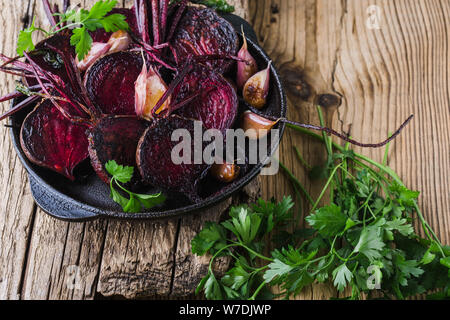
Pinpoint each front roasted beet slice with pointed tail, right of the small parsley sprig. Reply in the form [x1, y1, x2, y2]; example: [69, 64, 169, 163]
[136, 116, 209, 202]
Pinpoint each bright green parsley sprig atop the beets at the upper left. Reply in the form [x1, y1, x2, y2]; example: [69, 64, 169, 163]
[17, 0, 129, 61]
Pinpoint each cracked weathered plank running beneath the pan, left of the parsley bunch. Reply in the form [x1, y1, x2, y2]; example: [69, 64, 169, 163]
[17, 0, 254, 299]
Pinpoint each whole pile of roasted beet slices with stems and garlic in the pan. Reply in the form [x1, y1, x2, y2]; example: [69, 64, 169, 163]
[2, 0, 243, 202]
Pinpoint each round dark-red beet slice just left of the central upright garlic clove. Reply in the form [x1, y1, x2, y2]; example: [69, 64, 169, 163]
[85, 51, 143, 115]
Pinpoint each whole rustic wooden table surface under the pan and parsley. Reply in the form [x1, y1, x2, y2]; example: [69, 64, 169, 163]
[0, 0, 450, 299]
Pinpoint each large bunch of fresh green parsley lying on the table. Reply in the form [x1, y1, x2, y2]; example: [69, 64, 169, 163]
[192, 109, 450, 299]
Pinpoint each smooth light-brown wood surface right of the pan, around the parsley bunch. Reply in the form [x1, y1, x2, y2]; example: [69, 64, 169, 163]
[250, 0, 450, 298]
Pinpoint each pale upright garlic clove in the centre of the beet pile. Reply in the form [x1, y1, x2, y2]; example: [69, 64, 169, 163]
[135, 63, 171, 120]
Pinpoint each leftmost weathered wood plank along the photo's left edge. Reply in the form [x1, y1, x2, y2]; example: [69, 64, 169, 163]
[0, 1, 35, 300]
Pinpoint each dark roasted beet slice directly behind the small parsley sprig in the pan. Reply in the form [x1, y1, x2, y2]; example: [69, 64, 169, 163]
[89, 116, 148, 184]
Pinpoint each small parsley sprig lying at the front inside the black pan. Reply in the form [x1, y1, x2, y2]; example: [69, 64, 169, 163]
[105, 160, 166, 213]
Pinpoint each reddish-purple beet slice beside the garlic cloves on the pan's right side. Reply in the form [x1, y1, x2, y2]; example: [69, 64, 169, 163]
[174, 65, 238, 132]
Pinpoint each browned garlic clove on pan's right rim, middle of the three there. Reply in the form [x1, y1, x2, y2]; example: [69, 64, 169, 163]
[242, 61, 272, 109]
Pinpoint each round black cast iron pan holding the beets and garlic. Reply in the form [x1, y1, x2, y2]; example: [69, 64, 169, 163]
[11, 14, 287, 221]
